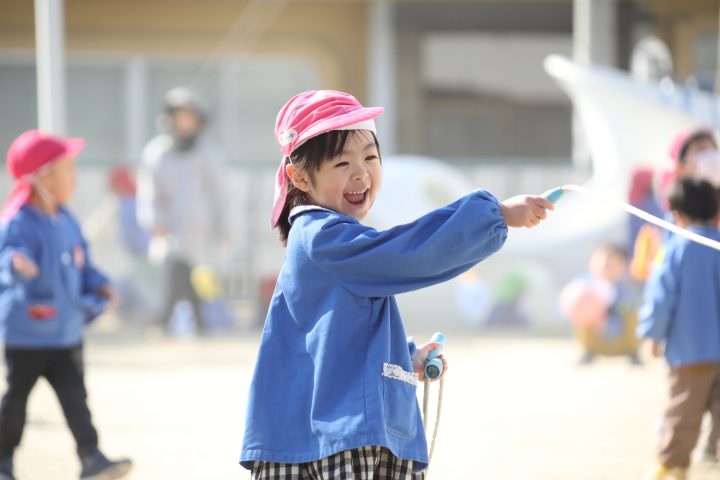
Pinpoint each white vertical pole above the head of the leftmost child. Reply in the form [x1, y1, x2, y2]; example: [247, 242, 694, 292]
[35, 0, 66, 135]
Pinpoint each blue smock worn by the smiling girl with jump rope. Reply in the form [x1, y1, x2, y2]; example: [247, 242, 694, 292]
[240, 190, 507, 469]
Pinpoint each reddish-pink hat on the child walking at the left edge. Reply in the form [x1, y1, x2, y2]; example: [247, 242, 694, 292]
[0, 130, 85, 221]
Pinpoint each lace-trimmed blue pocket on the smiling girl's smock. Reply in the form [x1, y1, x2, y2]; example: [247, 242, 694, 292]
[382, 363, 417, 439]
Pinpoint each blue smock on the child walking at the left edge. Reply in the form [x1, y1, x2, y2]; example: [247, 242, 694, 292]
[0, 205, 110, 348]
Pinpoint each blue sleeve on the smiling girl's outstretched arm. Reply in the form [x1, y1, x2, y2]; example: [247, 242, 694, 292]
[301, 190, 507, 297]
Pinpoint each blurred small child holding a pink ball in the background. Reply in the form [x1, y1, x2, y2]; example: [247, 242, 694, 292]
[560, 244, 640, 365]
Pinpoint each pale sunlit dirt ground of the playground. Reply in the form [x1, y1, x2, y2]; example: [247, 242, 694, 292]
[2, 331, 720, 480]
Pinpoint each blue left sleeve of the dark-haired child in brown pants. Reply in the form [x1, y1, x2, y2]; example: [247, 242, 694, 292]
[637, 242, 681, 340]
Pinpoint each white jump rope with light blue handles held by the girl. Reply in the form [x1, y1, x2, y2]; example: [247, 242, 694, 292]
[423, 184, 720, 474]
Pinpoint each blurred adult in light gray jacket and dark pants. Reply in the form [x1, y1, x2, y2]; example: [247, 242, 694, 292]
[138, 87, 228, 332]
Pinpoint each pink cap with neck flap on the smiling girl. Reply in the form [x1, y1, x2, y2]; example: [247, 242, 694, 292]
[270, 90, 383, 228]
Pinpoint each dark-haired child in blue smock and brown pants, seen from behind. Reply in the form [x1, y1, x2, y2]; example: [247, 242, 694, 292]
[637, 179, 720, 479]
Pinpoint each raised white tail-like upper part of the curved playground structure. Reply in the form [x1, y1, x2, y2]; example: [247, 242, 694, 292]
[545, 55, 719, 186]
